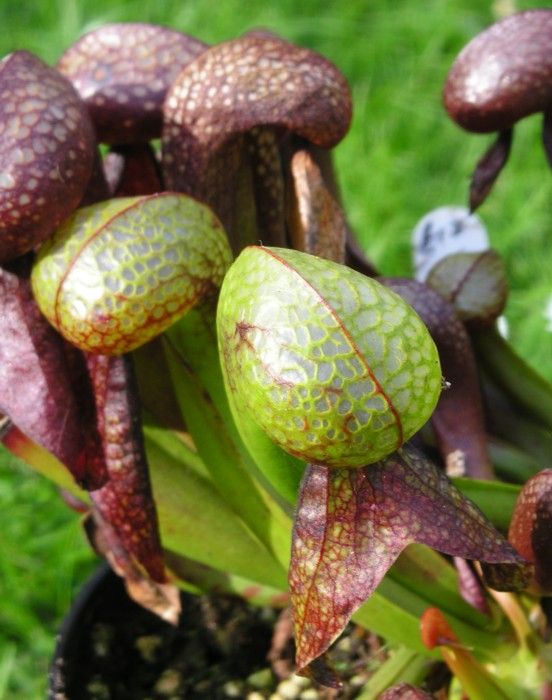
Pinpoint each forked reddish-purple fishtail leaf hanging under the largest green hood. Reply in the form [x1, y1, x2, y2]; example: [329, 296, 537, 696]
[289, 446, 522, 669]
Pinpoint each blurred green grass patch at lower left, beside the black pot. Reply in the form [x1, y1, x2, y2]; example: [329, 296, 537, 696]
[0, 454, 94, 700]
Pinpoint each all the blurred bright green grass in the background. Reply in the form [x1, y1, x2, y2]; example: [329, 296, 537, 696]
[0, 0, 552, 700]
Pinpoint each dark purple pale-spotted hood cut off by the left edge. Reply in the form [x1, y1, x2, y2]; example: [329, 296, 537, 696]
[0, 51, 95, 261]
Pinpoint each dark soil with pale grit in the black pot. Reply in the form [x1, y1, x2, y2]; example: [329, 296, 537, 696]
[50, 575, 388, 700]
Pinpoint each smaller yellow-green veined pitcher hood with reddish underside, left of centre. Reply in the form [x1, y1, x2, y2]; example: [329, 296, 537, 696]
[32, 194, 230, 355]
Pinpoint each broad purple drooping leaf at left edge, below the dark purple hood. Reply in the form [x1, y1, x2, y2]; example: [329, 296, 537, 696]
[0, 259, 105, 489]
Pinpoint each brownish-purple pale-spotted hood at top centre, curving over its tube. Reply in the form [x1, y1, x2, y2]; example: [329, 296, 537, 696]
[163, 35, 351, 196]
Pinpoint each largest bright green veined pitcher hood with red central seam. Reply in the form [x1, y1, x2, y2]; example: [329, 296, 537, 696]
[218, 246, 441, 467]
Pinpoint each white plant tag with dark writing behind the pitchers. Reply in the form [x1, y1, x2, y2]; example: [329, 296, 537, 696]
[412, 207, 489, 282]
